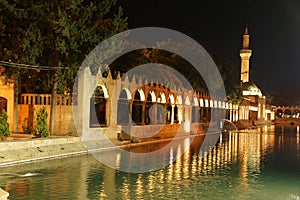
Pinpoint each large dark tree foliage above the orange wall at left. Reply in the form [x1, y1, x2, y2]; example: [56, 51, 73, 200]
[0, 0, 127, 93]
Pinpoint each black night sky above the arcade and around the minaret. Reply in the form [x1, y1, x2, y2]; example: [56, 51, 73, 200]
[120, 0, 300, 93]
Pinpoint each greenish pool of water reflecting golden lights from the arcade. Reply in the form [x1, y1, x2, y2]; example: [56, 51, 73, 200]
[0, 126, 300, 200]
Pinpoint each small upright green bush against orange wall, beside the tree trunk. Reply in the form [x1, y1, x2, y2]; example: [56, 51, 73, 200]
[35, 107, 50, 137]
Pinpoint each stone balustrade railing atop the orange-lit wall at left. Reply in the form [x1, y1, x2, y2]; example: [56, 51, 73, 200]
[19, 94, 72, 106]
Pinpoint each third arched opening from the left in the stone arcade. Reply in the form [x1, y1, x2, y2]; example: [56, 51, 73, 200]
[132, 91, 143, 125]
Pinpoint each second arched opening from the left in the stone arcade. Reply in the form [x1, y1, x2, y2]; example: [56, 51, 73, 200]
[117, 89, 131, 125]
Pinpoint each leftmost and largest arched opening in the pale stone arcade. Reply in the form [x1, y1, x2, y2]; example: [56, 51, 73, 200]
[90, 86, 108, 127]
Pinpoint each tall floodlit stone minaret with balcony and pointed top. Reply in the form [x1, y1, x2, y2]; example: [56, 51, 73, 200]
[240, 26, 252, 83]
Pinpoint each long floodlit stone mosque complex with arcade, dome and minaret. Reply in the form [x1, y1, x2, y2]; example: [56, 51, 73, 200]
[0, 27, 275, 137]
